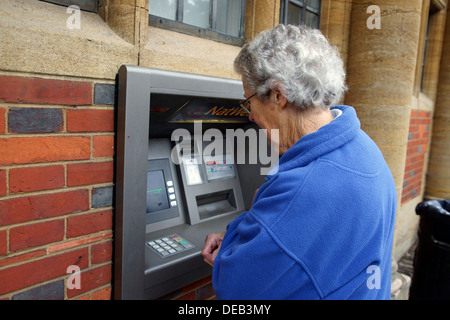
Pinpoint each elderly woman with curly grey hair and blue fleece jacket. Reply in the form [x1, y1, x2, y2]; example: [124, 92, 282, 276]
[202, 25, 397, 299]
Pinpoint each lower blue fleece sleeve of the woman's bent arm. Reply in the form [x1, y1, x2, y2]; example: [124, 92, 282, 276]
[213, 212, 320, 300]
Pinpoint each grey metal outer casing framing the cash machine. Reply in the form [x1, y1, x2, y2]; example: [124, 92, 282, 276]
[114, 65, 268, 299]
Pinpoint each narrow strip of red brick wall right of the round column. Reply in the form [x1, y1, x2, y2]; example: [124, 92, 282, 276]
[402, 110, 431, 204]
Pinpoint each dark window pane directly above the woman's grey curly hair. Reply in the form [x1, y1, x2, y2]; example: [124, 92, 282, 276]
[280, 0, 321, 29]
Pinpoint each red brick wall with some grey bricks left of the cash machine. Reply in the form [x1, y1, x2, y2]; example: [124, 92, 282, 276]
[0, 75, 114, 299]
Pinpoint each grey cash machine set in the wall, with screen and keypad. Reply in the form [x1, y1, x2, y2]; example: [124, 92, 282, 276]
[114, 65, 273, 299]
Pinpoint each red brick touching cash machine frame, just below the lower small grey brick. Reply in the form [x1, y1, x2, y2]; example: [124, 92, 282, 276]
[67, 211, 112, 238]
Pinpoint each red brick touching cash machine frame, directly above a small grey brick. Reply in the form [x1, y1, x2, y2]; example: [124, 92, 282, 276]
[67, 161, 114, 187]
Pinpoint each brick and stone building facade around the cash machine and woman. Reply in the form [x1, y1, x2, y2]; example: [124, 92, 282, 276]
[0, 0, 450, 300]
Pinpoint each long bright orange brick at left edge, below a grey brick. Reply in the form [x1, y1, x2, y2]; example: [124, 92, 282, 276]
[0, 137, 91, 165]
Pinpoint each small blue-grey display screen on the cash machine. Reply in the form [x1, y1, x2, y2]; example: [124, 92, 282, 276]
[147, 170, 169, 213]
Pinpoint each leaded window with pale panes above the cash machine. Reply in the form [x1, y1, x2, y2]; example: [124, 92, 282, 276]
[149, 0, 245, 45]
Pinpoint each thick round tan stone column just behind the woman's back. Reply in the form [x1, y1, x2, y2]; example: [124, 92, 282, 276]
[345, 0, 422, 297]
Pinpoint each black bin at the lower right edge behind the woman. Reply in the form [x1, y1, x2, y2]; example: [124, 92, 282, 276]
[409, 200, 450, 300]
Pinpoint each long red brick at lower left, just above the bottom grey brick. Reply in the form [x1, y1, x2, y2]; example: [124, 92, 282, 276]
[0, 248, 89, 295]
